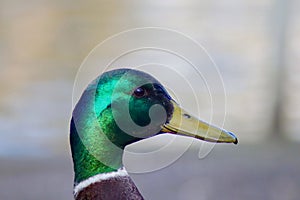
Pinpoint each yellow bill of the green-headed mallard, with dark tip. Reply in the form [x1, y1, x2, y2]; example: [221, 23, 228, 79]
[161, 100, 238, 144]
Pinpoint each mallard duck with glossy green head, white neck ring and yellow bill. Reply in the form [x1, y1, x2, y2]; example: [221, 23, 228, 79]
[70, 69, 238, 200]
